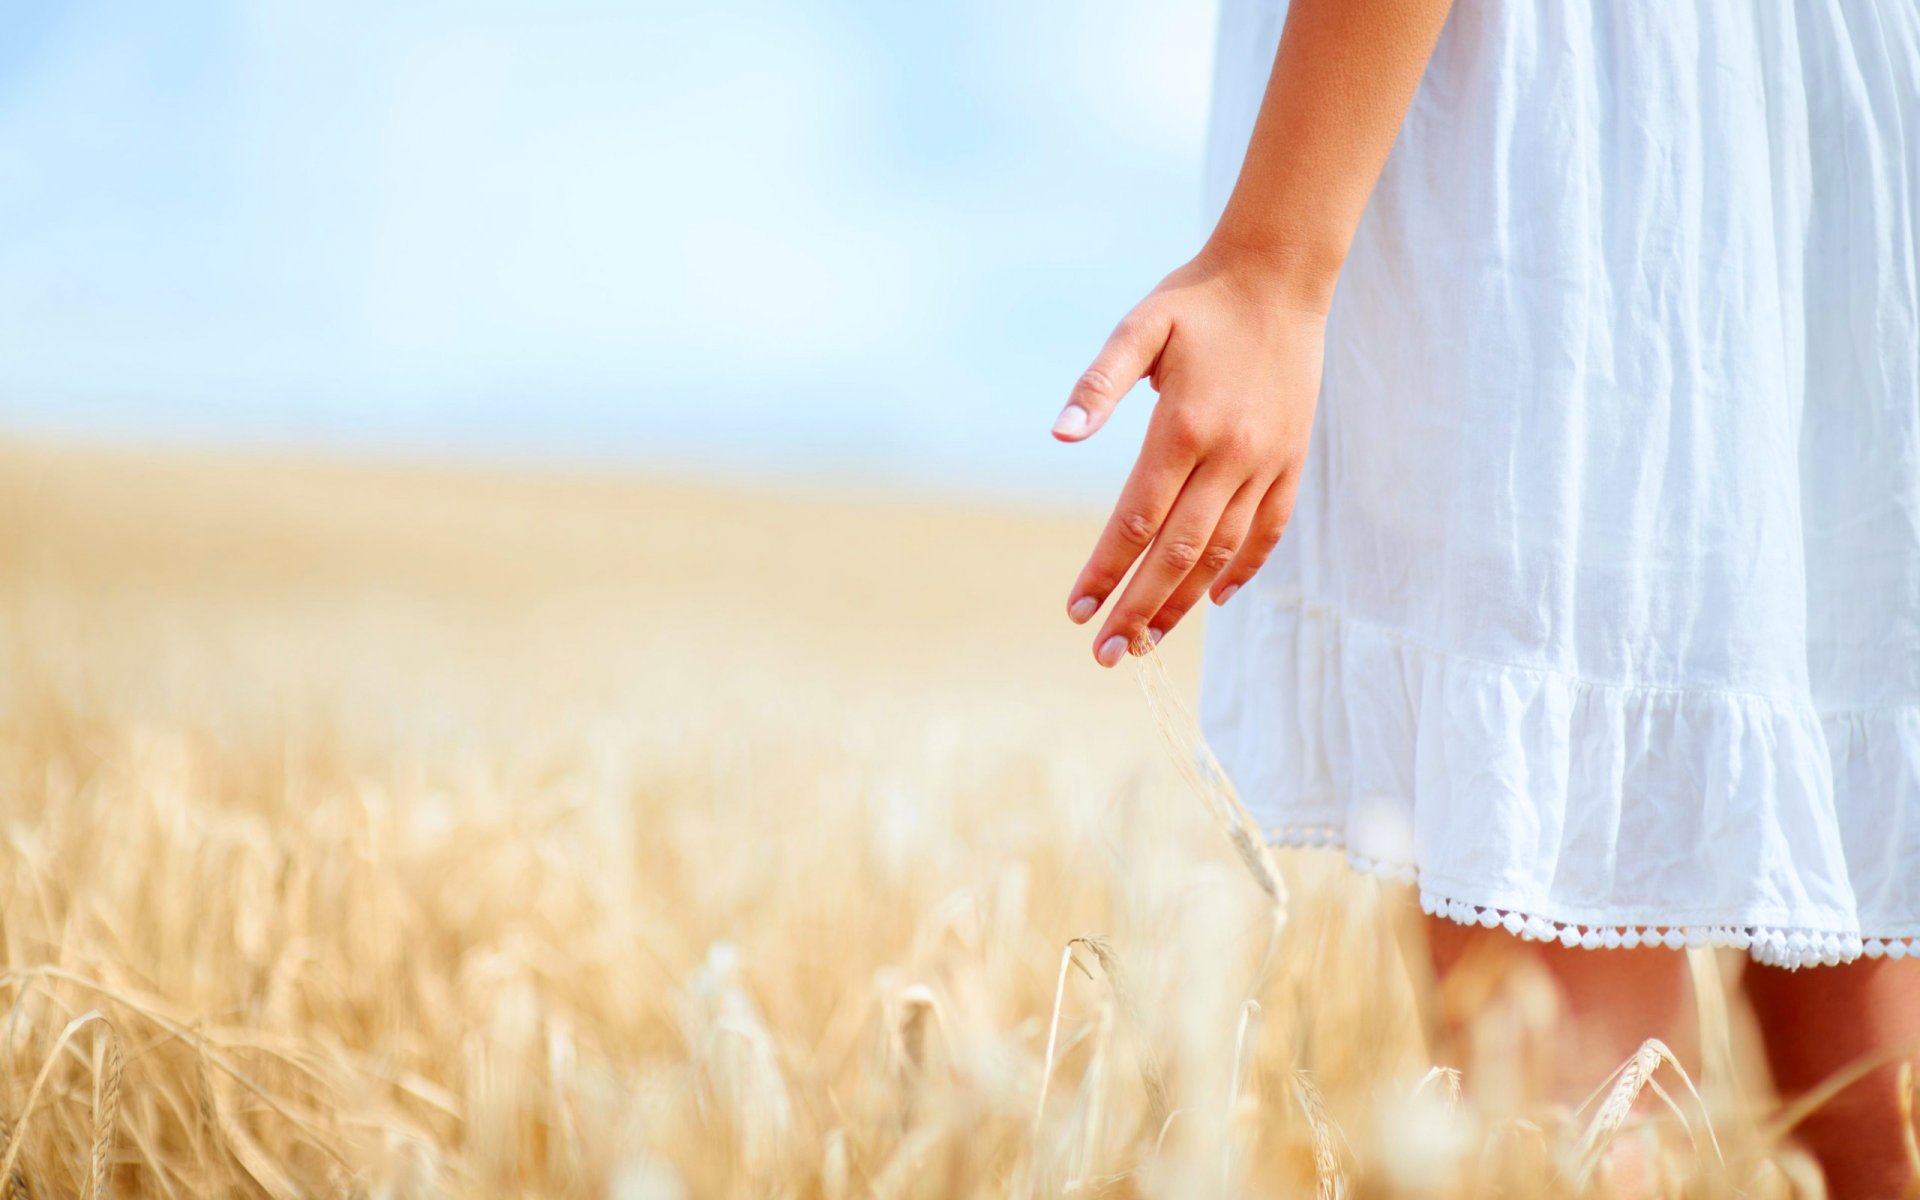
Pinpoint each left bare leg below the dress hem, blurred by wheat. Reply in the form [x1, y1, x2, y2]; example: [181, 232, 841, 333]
[1425, 918, 1697, 1104]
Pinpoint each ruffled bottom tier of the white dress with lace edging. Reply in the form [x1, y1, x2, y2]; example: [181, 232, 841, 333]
[1200, 588, 1920, 966]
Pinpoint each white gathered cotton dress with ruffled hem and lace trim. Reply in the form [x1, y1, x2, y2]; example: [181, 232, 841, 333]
[1200, 0, 1920, 966]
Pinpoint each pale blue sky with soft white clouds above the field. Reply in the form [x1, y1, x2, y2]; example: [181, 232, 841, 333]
[0, 0, 1213, 499]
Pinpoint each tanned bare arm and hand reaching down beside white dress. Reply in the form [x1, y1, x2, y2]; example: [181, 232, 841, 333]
[1054, 0, 1452, 666]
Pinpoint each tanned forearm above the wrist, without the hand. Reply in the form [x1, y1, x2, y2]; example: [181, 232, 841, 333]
[1206, 0, 1452, 311]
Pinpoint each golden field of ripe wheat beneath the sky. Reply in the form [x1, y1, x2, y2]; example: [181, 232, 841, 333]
[0, 445, 1843, 1200]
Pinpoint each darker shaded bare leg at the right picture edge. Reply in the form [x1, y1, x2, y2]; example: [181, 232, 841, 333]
[1743, 958, 1920, 1200]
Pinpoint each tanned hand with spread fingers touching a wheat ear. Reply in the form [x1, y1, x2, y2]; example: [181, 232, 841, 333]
[1054, 248, 1327, 666]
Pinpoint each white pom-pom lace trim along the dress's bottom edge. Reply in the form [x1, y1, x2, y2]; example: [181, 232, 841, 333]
[1265, 826, 1920, 968]
